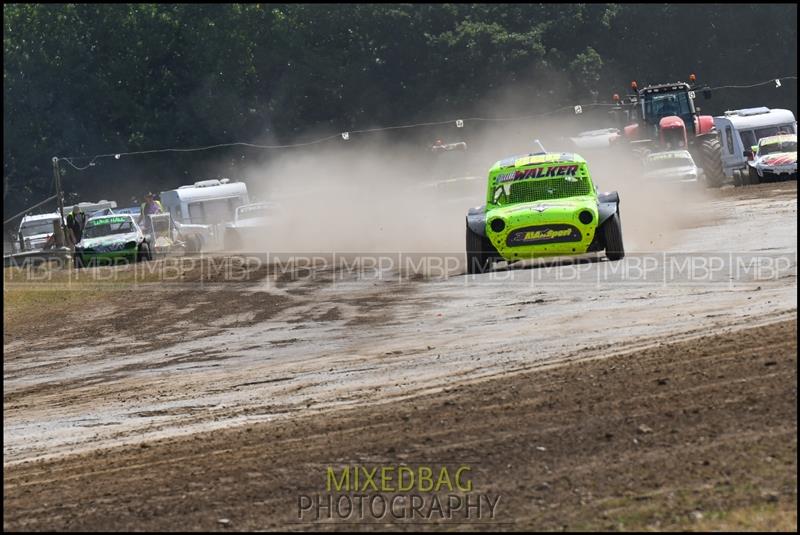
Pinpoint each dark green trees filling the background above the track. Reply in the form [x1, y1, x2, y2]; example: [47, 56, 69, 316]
[3, 4, 797, 216]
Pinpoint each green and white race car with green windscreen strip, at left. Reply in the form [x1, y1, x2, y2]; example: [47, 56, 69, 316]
[74, 214, 153, 268]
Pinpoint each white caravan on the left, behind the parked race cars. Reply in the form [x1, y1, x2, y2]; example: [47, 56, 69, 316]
[161, 178, 250, 250]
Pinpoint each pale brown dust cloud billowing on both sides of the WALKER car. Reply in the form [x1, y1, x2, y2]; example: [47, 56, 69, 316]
[234, 92, 708, 254]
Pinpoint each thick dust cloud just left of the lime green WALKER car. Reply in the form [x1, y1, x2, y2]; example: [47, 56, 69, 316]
[246, 139, 482, 253]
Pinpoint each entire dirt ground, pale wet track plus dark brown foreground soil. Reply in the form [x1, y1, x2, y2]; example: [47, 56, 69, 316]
[3, 182, 797, 530]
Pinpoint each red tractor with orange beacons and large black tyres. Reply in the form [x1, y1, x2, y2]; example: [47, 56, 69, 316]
[612, 74, 725, 187]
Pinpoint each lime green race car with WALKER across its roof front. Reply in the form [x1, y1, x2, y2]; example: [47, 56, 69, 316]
[467, 153, 625, 273]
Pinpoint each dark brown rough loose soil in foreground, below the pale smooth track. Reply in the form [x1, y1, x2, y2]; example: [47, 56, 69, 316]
[4, 321, 797, 530]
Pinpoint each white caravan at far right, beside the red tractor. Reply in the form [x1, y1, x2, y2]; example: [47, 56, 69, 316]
[714, 107, 797, 185]
